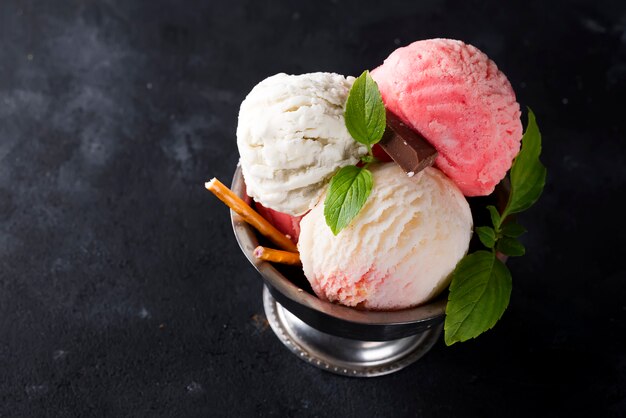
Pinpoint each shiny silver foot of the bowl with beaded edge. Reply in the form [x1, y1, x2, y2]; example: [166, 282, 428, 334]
[263, 286, 443, 377]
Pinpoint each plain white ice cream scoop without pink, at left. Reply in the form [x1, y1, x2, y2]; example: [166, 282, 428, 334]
[237, 73, 367, 216]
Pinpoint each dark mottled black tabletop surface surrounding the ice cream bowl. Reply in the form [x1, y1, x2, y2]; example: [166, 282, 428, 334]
[0, 0, 626, 417]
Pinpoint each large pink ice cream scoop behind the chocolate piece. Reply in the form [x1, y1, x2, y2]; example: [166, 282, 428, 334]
[372, 39, 522, 196]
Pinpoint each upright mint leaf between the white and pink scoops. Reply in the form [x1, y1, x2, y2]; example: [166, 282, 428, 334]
[344, 70, 387, 146]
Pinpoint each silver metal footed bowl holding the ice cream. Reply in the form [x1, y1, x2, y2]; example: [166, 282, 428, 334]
[231, 168, 447, 377]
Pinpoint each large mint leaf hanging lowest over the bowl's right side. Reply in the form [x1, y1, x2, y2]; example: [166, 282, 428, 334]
[444, 251, 512, 345]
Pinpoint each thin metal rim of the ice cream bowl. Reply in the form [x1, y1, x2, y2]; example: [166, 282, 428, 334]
[230, 164, 447, 326]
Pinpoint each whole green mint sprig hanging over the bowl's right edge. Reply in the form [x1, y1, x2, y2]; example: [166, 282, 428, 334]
[444, 108, 546, 345]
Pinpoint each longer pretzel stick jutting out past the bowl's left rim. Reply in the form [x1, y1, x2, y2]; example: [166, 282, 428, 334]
[204, 177, 298, 253]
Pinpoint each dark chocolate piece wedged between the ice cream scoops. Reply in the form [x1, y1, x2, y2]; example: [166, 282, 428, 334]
[379, 110, 437, 177]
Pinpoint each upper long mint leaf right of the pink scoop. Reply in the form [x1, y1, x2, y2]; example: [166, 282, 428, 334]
[502, 108, 546, 219]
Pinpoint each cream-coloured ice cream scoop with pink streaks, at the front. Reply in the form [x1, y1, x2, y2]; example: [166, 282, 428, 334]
[298, 163, 473, 310]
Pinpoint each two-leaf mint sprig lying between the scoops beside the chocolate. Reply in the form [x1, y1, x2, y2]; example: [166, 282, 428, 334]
[324, 70, 387, 235]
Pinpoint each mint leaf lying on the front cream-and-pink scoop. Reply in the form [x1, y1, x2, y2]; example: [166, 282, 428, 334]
[324, 165, 374, 235]
